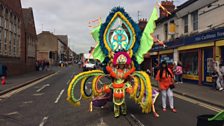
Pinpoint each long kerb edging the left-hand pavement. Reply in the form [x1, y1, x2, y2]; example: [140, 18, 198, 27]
[0, 72, 56, 96]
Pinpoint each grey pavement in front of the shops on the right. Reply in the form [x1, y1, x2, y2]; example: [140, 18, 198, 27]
[151, 78, 224, 109]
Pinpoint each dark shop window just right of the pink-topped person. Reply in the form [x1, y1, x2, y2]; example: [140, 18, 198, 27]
[180, 52, 198, 75]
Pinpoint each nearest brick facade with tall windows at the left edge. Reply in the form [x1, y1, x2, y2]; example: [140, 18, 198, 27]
[0, 0, 35, 75]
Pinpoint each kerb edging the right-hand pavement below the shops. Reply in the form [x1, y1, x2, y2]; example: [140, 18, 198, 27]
[152, 85, 224, 109]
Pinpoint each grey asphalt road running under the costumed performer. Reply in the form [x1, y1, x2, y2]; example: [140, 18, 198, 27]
[0, 65, 219, 126]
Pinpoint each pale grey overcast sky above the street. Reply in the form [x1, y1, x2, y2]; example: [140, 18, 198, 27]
[21, 0, 187, 53]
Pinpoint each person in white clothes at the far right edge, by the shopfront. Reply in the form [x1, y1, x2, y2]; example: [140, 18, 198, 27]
[213, 61, 223, 91]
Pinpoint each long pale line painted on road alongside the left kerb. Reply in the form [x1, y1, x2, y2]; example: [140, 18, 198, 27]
[1, 72, 58, 99]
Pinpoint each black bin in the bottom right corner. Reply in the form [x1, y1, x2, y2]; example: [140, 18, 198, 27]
[197, 115, 224, 126]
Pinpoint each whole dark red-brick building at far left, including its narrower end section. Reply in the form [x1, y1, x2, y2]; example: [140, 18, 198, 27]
[0, 0, 36, 75]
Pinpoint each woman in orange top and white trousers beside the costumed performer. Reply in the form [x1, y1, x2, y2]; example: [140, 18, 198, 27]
[156, 61, 176, 112]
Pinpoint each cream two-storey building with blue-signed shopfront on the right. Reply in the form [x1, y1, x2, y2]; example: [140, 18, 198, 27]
[149, 0, 224, 85]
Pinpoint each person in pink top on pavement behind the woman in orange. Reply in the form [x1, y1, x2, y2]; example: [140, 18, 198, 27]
[175, 61, 183, 84]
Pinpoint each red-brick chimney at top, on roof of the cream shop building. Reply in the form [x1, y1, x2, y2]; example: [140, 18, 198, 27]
[159, 0, 175, 17]
